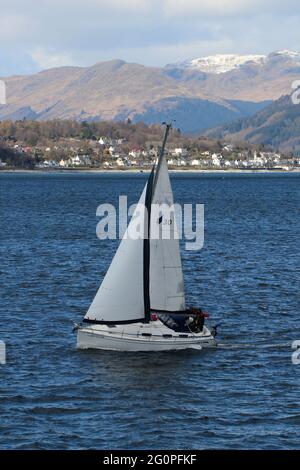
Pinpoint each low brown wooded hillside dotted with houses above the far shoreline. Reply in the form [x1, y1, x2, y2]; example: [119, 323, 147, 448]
[0, 119, 292, 171]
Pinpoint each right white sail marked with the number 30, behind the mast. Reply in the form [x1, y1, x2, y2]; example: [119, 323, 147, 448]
[150, 152, 185, 311]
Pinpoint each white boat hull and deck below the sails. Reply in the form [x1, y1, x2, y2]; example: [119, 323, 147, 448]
[77, 321, 216, 351]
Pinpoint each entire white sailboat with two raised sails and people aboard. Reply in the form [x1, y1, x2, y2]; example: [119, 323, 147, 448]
[75, 123, 216, 351]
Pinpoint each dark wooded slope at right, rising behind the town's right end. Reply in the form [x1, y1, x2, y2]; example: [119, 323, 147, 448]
[207, 95, 300, 151]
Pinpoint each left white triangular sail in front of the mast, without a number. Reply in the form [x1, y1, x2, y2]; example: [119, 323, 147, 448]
[85, 184, 147, 323]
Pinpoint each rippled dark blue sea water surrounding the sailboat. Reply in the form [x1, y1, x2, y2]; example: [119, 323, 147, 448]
[0, 172, 300, 449]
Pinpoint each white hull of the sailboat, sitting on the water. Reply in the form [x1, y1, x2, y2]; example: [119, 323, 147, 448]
[77, 327, 216, 351]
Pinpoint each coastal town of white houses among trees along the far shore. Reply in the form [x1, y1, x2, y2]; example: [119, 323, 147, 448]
[0, 119, 300, 171]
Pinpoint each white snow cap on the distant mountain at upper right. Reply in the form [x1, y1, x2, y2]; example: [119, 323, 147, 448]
[173, 50, 300, 74]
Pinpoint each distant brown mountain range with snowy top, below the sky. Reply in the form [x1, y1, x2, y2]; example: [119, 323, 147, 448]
[0, 51, 300, 132]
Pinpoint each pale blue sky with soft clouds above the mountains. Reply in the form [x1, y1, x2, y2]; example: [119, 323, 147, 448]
[0, 0, 300, 77]
